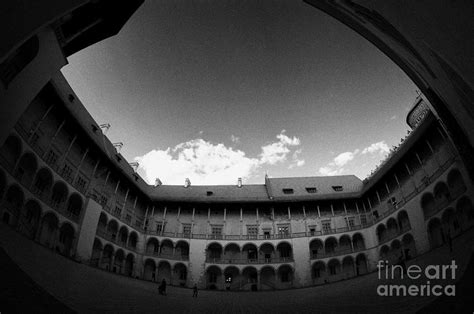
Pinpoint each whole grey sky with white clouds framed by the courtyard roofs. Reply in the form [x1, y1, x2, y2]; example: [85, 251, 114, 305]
[62, 0, 417, 184]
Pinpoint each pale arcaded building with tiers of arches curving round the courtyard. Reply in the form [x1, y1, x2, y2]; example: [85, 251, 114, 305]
[0, 1, 474, 290]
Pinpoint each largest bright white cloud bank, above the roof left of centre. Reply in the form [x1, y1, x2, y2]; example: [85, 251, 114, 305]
[135, 130, 304, 185]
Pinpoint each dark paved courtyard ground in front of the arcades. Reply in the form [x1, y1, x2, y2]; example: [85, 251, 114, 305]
[0, 224, 474, 313]
